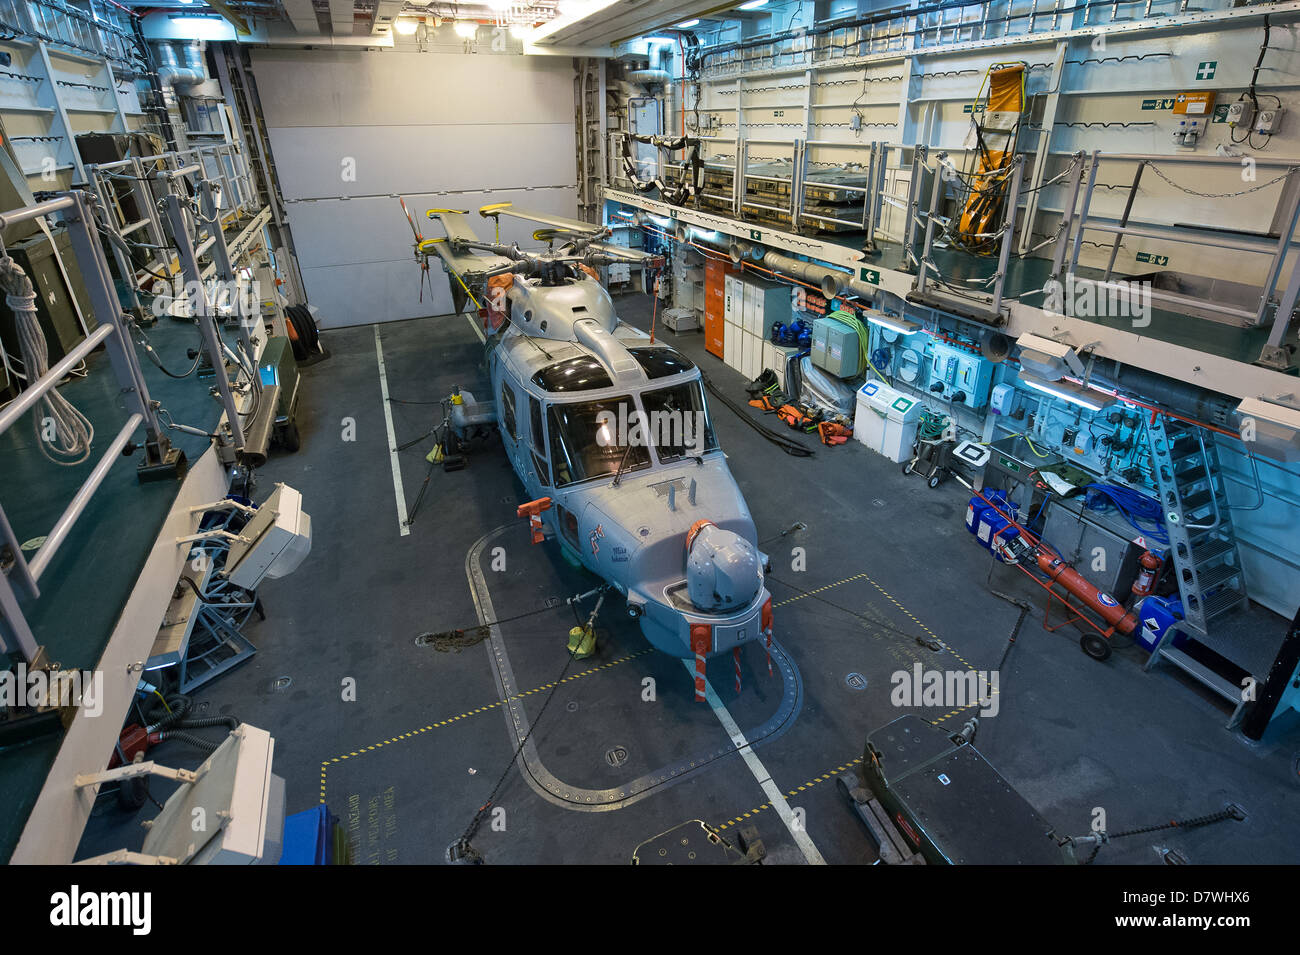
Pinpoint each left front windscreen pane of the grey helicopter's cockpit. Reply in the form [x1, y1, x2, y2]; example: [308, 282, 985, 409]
[550, 395, 650, 487]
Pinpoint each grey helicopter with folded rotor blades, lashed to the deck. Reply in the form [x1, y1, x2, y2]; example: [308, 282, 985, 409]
[402, 201, 772, 699]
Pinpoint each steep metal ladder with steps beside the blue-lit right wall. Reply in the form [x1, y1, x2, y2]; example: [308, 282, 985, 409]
[1144, 414, 1260, 728]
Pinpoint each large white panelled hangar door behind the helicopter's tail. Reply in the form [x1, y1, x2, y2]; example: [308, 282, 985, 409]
[251, 49, 577, 327]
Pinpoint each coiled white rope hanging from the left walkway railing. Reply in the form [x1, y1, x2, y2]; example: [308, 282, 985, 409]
[0, 256, 95, 466]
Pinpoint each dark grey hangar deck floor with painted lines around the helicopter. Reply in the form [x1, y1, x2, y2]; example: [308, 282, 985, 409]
[79, 295, 1300, 864]
